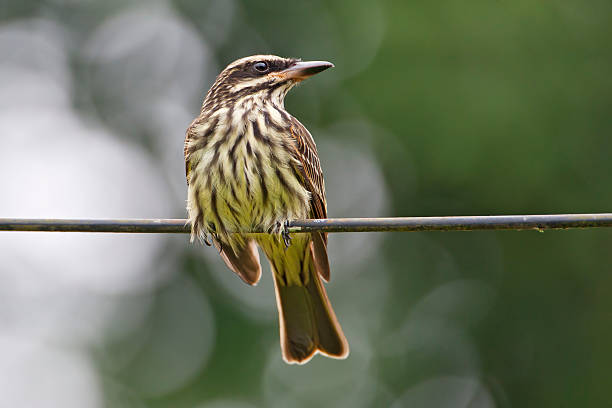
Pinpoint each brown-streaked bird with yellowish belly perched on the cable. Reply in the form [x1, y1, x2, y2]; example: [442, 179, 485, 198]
[184, 55, 349, 364]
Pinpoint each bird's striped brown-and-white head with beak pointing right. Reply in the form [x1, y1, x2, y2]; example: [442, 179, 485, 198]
[204, 55, 334, 109]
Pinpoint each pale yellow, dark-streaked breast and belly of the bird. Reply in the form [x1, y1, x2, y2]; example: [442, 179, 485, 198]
[188, 108, 310, 236]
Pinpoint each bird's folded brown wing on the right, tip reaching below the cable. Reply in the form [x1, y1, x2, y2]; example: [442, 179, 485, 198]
[291, 118, 330, 281]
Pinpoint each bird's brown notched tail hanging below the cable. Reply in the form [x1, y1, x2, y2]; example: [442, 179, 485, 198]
[271, 239, 349, 364]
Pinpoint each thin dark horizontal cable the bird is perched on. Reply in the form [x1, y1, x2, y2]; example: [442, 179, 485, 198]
[0, 213, 612, 233]
